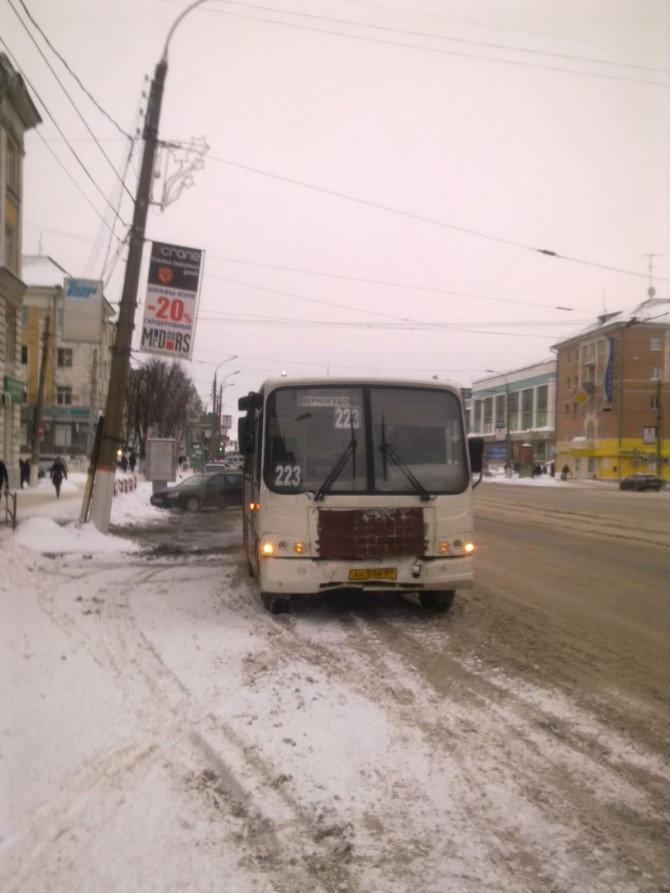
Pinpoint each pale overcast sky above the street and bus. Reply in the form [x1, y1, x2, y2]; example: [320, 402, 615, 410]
[0, 0, 670, 411]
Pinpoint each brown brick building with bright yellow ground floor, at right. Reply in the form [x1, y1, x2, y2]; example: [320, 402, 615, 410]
[552, 289, 670, 480]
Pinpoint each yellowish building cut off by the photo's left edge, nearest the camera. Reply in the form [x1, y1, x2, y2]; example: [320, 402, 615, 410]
[0, 53, 42, 487]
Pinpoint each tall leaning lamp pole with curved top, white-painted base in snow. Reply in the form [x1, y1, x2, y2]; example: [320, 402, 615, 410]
[88, 0, 211, 533]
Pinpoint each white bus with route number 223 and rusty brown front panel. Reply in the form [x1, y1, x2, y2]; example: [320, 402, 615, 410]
[238, 377, 482, 613]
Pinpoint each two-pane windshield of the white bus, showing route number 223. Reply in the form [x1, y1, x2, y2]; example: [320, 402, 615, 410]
[264, 383, 469, 500]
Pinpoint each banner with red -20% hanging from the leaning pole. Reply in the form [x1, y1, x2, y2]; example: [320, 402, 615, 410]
[140, 242, 205, 360]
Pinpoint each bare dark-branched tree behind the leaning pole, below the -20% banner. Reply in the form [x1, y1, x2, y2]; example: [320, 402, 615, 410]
[125, 359, 202, 458]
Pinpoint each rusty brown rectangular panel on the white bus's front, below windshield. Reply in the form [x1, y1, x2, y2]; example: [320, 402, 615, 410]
[318, 507, 424, 559]
